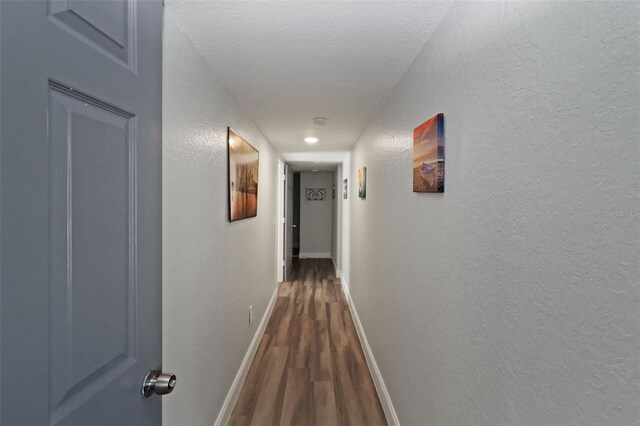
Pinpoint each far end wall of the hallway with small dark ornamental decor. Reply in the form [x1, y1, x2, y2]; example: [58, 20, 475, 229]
[299, 172, 333, 257]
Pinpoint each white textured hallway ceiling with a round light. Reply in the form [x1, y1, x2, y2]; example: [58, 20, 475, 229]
[166, 0, 451, 152]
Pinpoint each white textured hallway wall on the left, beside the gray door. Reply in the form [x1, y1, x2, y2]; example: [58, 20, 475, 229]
[163, 13, 277, 426]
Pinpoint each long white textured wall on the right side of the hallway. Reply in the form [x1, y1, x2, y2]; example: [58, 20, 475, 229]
[349, 2, 640, 425]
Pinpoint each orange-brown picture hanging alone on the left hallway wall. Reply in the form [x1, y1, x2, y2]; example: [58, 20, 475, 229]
[227, 128, 259, 222]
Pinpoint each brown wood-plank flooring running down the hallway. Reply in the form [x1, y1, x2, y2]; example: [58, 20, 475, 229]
[229, 259, 387, 426]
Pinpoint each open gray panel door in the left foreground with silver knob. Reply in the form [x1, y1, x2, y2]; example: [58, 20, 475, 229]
[0, 0, 162, 425]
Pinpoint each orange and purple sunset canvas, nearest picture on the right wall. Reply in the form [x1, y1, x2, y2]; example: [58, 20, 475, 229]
[413, 113, 444, 192]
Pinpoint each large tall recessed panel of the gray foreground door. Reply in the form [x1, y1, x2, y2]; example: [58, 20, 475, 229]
[49, 84, 136, 411]
